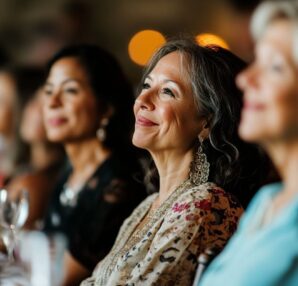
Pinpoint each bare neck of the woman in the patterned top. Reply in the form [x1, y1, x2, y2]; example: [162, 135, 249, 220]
[151, 150, 193, 207]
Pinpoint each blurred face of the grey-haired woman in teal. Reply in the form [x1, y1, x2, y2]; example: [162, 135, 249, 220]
[237, 20, 298, 144]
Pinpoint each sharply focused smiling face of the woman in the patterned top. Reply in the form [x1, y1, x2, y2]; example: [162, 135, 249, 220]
[133, 52, 202, 151]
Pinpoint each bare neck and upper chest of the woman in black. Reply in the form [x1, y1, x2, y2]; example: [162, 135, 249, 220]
[65, 138, 111, 186]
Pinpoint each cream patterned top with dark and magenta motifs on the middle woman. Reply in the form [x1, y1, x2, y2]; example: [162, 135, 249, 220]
[81, 180, 242, 286]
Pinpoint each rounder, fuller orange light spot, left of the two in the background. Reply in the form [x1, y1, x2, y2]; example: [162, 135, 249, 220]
[128, 30, 166, 66]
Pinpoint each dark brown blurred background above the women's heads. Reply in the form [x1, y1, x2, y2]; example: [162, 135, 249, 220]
[0, 0, 260, 85]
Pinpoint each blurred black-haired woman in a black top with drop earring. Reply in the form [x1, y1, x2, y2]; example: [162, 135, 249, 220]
[43, 45, 145, 285]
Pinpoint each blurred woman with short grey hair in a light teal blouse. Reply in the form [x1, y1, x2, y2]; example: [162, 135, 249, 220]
[198, 0, 298, 286]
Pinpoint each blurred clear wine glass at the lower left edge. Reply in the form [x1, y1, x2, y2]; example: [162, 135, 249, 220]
[0, 189, 29, 262]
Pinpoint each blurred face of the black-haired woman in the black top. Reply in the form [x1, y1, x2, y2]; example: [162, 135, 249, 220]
[43, 57, 99, 143]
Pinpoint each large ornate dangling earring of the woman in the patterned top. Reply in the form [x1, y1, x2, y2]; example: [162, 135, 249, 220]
[189, 136, 210, 185]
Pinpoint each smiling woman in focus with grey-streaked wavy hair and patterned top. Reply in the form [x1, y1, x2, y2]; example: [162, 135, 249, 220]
[82, 40, 268, 286]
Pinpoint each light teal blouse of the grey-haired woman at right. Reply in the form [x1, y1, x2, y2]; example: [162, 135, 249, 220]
[197, 183, 298, 286]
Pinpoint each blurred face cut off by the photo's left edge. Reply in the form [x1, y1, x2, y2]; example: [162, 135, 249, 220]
[0, 72, 16, 136]
